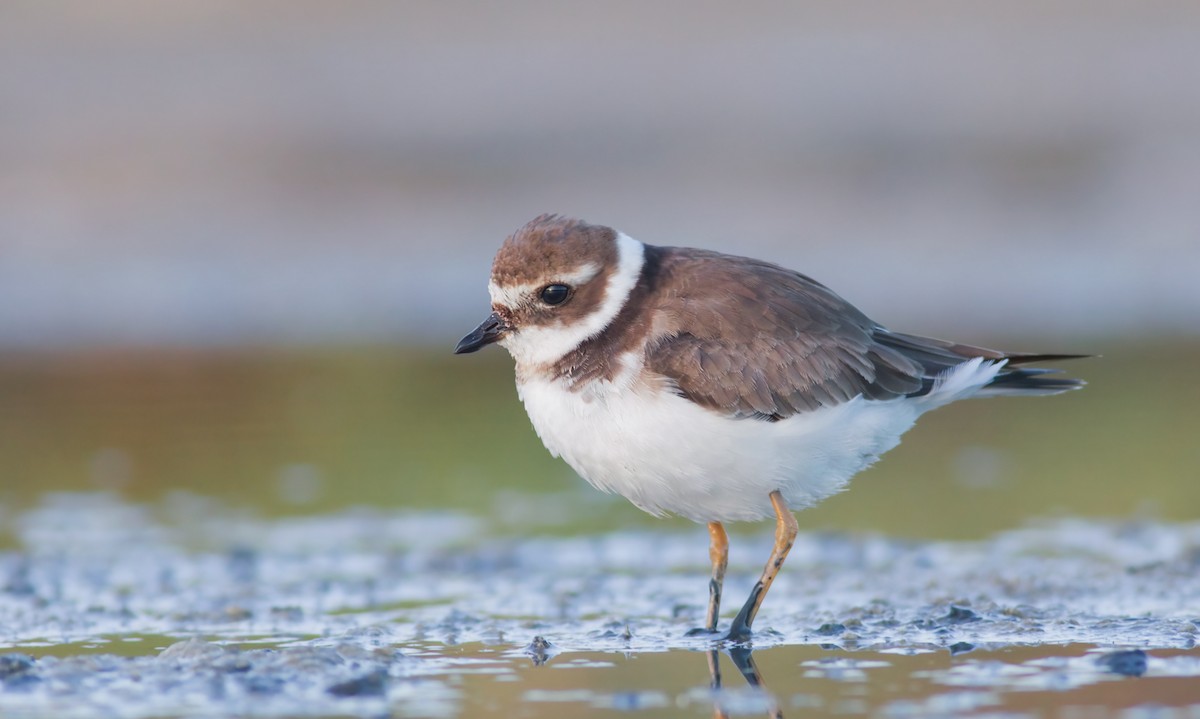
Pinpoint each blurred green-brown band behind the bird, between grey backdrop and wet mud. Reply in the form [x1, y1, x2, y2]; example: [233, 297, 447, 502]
[0, 343, 1200, 538]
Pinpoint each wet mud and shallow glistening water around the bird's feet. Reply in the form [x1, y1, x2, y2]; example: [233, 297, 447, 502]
[0, 493, 1200, 717]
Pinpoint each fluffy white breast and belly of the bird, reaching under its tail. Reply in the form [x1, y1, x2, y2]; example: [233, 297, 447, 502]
[517, 363, 998, 522]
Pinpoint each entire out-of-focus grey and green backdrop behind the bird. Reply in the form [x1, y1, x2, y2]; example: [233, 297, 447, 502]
[0, 0, 1200, 543]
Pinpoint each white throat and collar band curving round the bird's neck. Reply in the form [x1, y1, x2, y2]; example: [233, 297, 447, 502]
[493, 232, 646, 367]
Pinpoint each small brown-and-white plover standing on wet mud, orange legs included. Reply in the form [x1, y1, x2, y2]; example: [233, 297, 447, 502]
[454, 214, 1088, 645]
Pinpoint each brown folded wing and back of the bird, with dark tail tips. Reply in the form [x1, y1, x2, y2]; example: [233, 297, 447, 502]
[646, 248, 1094, 420]
